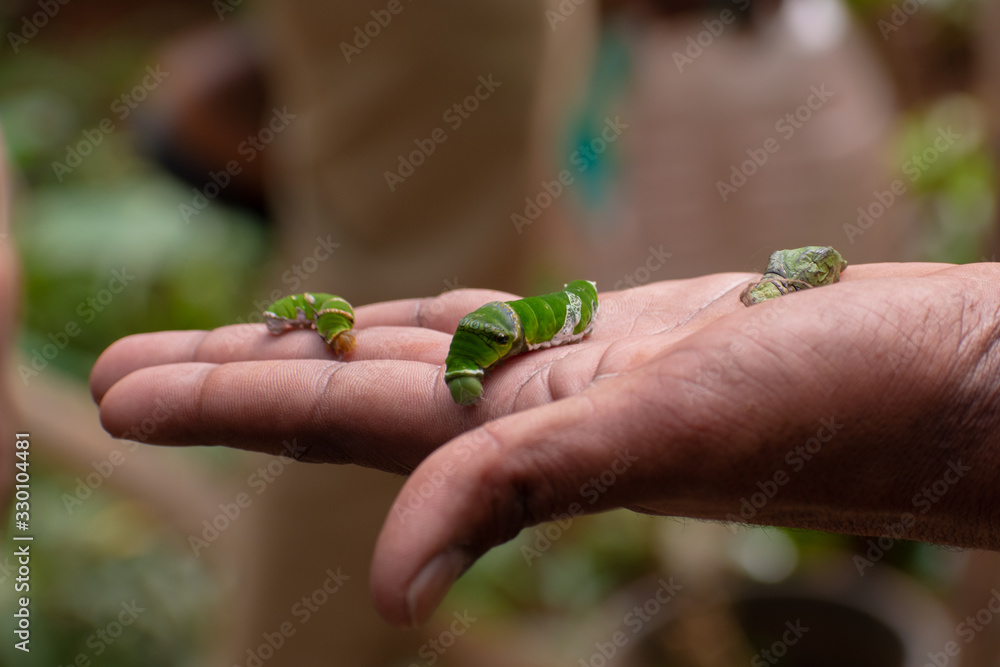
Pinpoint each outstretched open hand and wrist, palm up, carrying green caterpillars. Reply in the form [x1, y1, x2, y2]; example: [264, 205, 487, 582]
[91, 264, 1000, 627]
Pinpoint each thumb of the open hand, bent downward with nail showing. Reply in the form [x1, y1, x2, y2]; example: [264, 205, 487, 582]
[371, 378, 639, 627]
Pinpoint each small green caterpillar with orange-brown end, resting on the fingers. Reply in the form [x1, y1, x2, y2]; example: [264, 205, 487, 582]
[264, 292, 357, 354]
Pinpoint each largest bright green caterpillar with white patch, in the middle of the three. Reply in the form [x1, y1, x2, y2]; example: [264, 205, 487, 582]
[444, 280, 600, 405]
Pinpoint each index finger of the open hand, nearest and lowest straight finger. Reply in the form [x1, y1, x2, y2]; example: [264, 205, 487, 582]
[100, 360, 470, 473]
